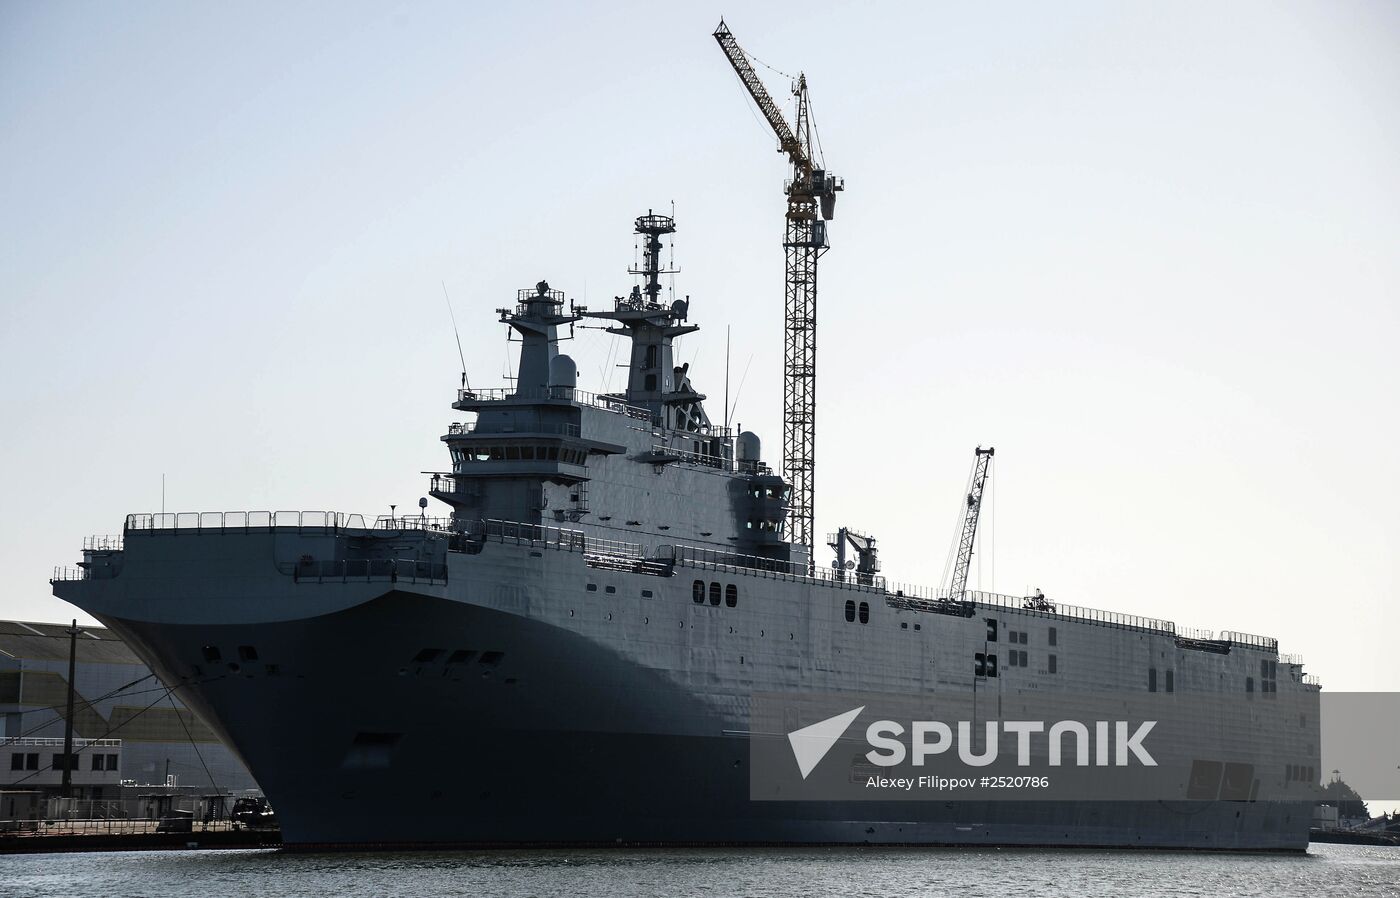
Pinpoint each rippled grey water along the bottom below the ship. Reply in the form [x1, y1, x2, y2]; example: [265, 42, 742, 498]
[0, 845, 1400, 898]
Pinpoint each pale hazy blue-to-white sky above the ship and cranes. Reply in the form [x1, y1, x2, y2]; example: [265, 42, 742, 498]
[0, 0, 1400, 689]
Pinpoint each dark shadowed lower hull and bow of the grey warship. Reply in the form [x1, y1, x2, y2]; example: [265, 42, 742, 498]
[65, 584, 1309, 850]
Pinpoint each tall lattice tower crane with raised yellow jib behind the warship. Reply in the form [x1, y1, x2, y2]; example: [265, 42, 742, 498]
[714, 20, 846, 567]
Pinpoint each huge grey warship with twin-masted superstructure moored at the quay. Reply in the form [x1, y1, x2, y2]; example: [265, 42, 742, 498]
[52, 213, 1319, 850]
